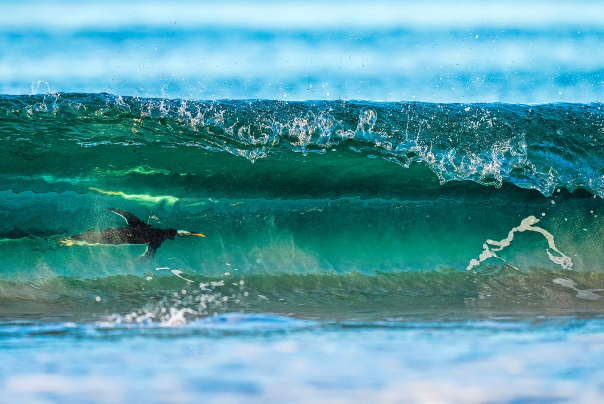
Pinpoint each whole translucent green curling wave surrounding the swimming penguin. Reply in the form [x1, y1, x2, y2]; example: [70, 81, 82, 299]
[0, 94, 604, 318]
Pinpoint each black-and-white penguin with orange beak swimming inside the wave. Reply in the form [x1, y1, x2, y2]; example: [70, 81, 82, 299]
[57, 208, 205, 262]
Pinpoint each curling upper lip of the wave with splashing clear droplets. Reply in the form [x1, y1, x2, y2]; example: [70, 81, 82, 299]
[0, 94, 604, 196]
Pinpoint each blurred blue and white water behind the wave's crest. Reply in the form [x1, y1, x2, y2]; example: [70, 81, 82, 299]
[0, 0, 604, 103]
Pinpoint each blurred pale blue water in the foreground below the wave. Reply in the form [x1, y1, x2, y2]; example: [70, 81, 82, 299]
[0, 314, 604, 403]
